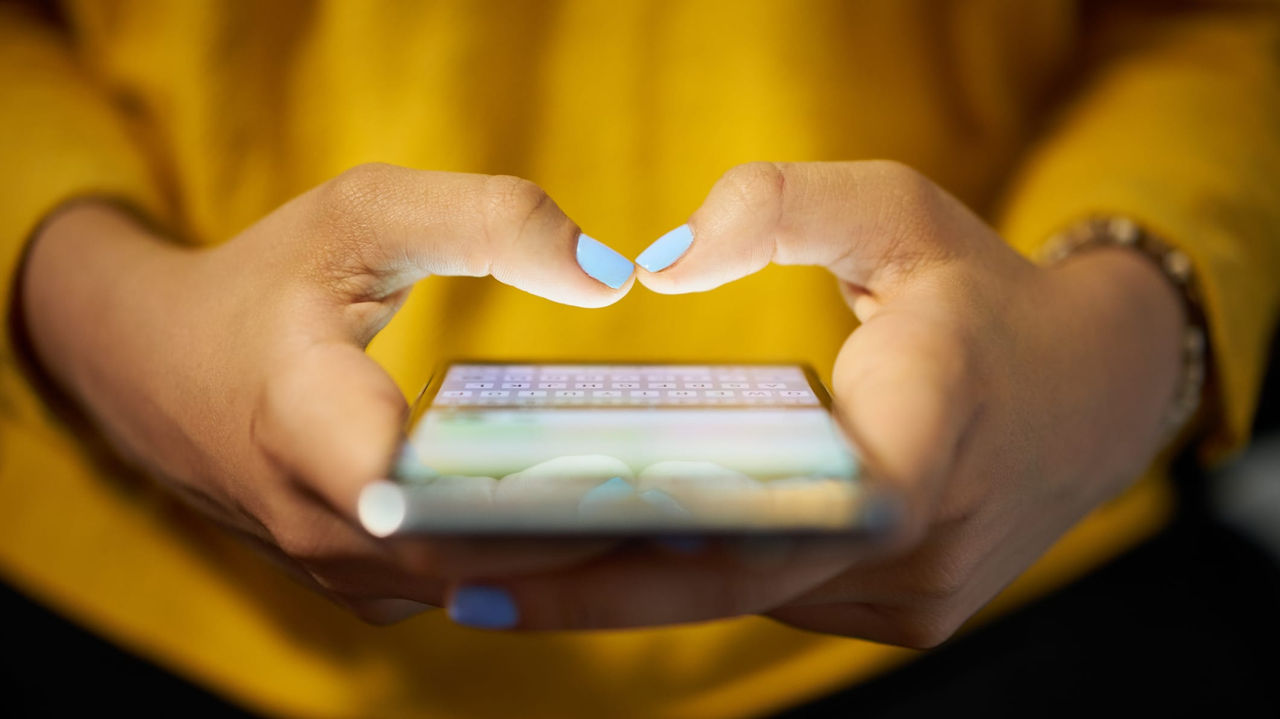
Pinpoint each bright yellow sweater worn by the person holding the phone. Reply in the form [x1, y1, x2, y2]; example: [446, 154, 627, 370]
[0, 0, 1280, 716]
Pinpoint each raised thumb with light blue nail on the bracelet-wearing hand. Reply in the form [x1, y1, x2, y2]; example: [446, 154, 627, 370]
[639, 161, 980, 294]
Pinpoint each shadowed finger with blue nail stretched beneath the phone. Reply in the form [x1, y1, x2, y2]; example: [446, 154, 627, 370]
[448, 542, 859, 629]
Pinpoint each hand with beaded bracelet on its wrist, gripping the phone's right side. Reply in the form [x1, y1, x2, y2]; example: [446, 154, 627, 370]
[451, 162, 1183, 646]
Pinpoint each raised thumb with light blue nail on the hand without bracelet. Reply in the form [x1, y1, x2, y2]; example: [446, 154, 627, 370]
[292, 164, 632, 307]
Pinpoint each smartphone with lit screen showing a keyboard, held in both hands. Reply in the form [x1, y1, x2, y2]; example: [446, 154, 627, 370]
[360, 361, 887, 536]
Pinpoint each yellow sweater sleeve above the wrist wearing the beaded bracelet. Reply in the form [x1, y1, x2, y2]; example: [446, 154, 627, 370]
[1000, 4, 1280, 459]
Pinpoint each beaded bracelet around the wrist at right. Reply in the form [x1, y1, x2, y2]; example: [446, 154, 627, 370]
[1041, 217, 1208, 440]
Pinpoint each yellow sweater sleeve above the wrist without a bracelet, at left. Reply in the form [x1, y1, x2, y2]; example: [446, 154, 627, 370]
[0, 4, 159, 413]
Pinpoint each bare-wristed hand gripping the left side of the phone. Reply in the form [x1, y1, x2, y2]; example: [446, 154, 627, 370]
[23, 165, 634, 622]
